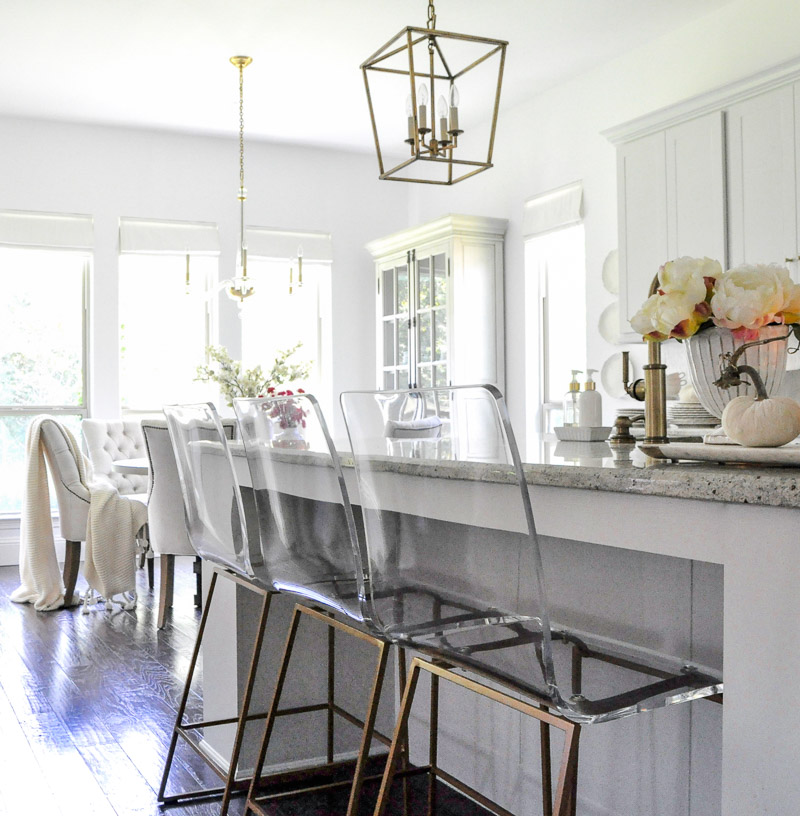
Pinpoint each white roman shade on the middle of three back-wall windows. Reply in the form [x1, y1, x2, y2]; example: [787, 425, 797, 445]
[119, 218, 219, 255]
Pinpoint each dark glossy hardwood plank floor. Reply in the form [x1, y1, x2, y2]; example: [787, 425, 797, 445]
[0, 558, 486, 816]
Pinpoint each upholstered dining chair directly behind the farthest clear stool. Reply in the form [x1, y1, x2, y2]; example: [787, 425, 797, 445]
[142, 419, 236, 629]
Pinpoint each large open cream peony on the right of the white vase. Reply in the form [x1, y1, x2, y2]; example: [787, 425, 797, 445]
[711, 264, 800, 329]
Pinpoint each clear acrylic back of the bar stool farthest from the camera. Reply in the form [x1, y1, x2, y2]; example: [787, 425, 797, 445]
[164, 403, 266, 582]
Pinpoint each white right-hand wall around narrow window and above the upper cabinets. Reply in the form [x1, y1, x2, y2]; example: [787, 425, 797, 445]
[410, 0, 800, 446]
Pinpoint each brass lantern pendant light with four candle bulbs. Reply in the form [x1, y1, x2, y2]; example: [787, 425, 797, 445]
[361, 2, 508, 185]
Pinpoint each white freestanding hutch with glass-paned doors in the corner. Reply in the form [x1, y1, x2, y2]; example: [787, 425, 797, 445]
[367, 215, 507, 389]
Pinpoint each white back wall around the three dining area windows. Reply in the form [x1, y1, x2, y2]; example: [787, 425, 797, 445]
[0, 118, 408, 433]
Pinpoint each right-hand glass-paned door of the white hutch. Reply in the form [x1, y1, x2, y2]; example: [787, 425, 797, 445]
[412, 252, 449, 388]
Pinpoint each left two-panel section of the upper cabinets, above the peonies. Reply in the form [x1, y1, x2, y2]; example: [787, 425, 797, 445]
[617, 111, 726, 340]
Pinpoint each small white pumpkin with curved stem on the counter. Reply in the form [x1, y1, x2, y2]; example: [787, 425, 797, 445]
[722, 396, 800, 448]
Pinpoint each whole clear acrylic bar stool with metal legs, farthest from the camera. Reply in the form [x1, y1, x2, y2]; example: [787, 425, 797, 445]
[158, 403, 274, 816]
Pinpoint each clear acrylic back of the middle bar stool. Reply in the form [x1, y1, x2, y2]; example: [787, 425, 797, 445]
[234, 393, 364, 621]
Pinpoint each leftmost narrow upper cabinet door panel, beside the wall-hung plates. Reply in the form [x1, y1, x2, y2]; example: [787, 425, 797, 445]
[617, 131, 669, 340]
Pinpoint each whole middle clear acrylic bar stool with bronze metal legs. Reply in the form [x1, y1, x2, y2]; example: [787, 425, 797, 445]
[234, 394, 405, 816]
